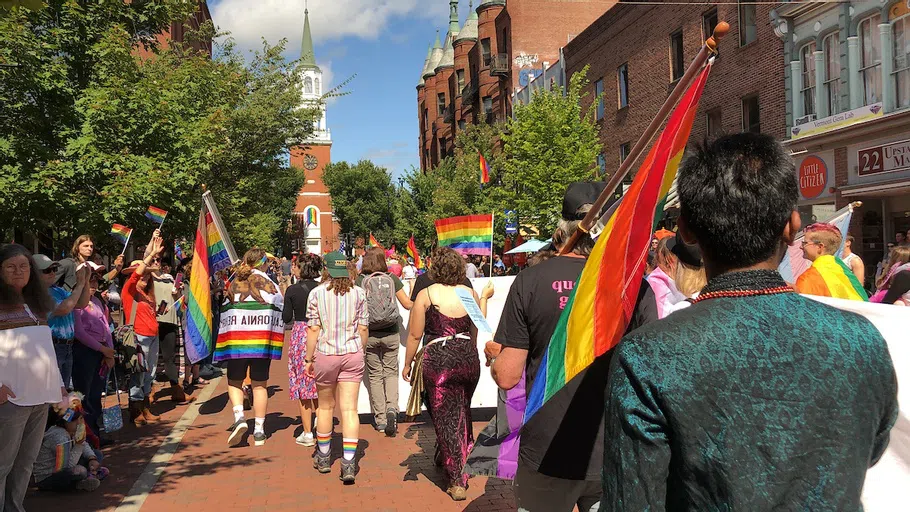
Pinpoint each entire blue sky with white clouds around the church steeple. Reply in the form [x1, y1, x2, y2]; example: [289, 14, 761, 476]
[209, 0, 476, 178]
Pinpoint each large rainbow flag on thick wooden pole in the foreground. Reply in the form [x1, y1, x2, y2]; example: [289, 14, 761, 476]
[524, 63, 711, 422]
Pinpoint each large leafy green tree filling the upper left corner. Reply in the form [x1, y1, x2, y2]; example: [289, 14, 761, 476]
[0, 0, 318, 254]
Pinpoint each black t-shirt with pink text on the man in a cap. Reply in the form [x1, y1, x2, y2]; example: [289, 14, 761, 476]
[496, 256, 657, 480]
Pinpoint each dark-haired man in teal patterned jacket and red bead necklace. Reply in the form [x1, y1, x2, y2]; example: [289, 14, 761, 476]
[601, 133, 898, 511]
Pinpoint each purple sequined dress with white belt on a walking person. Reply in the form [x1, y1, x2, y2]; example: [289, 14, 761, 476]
[423, 306, 480, 487]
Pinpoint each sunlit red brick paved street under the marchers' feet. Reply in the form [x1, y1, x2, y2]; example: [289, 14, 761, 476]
[26, 334, 515, 512]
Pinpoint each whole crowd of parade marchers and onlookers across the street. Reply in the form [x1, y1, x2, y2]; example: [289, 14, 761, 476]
[0, 133, 910, 512]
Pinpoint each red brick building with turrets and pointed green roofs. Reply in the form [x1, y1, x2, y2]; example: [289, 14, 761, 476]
[417, 0, 616, 172]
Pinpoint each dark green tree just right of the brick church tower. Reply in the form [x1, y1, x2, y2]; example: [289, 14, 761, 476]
[322, 160, 396, 240]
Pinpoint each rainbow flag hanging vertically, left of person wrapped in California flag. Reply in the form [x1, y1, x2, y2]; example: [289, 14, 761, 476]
[185, 206, 214, 363]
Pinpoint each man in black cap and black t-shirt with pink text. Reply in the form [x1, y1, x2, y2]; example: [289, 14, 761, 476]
[485, 182, 657, 512]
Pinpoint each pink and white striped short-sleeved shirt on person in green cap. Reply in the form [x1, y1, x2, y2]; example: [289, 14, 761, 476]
[307, 284, 370, 356]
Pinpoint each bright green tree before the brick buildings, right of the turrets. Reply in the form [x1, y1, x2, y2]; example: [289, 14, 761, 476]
[497, 67, 601, 236]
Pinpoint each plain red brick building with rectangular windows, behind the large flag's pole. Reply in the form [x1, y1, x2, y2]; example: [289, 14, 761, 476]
[563, 3, 787, 180]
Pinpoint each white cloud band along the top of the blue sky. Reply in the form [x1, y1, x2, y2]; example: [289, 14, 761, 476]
[210, 0, 467, 57]
